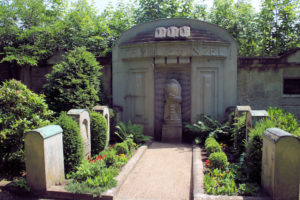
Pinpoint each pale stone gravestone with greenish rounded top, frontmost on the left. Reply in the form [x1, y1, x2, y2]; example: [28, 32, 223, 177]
[24, 125, 65, 193]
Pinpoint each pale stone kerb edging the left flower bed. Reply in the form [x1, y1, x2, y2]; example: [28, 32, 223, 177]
[44, 142, 151, 200]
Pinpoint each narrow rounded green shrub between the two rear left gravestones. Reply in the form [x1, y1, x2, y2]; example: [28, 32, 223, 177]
[90, 111, 109, 155]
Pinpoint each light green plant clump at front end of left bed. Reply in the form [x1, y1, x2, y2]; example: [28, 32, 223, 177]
[66, 160, 119, 196]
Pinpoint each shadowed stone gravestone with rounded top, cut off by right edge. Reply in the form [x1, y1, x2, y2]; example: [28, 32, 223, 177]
[261, 128, 300, 200]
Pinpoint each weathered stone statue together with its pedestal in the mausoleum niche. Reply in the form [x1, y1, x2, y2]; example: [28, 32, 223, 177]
[162, 79, 182, 143]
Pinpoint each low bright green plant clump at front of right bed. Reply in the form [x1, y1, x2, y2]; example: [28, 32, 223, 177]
[204, 169, 237, 195]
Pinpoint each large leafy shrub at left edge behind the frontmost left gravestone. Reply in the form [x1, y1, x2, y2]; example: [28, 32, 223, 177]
[0, 80, 53, 173]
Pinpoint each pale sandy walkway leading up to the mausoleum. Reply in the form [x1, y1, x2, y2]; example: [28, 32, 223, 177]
[117, 142, 192, 200]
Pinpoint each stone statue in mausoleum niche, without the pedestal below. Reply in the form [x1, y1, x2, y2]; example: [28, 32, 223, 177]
[164, 79, 181, 124]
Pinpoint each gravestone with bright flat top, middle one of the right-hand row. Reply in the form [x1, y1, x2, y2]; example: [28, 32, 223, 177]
[246, 110, 269, 139]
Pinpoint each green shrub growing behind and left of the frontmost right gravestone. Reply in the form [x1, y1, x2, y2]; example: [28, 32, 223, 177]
[246, 107, 300, 183]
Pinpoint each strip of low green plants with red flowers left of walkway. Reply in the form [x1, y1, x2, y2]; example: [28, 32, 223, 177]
[66, 141, 134, 196]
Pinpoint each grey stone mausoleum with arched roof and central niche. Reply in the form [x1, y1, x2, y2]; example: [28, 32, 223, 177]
[112, 19, 237, 140]
